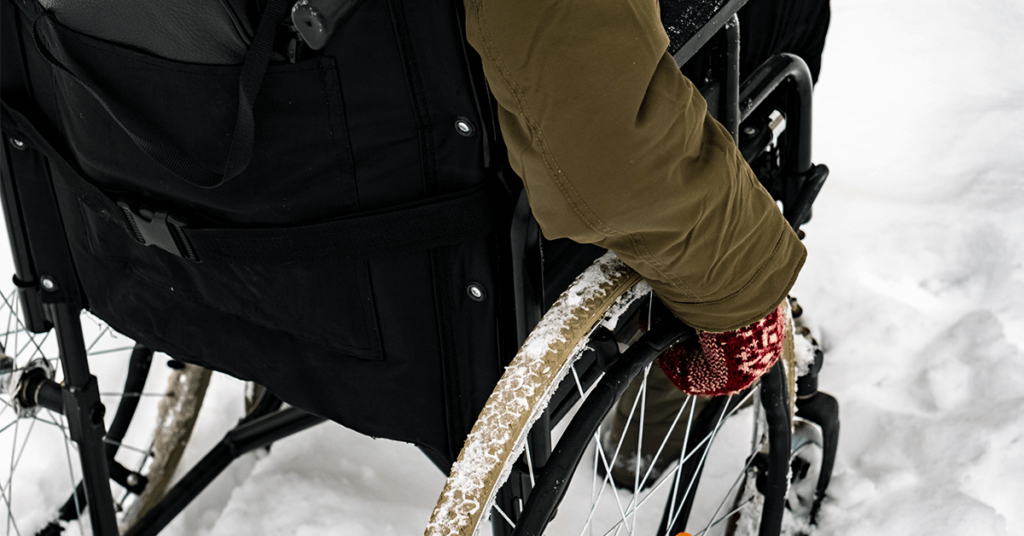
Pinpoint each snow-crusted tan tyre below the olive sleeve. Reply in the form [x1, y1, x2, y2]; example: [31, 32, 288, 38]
[425, 253, 650, 536]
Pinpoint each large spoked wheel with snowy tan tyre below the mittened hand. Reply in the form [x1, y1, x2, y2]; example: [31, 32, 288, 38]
[427, 255, 792, 536]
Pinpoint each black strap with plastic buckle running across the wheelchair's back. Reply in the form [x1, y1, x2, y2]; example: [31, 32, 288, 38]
[0, 101, 497, 263]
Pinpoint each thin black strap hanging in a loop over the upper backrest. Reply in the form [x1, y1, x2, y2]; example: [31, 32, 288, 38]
[33, 0, 289, 189]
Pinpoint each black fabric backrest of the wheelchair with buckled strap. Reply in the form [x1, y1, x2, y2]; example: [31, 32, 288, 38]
[2, 0, 515, 462]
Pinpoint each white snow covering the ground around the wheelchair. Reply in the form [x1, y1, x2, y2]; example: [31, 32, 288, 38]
[0, 0, 1024, 536]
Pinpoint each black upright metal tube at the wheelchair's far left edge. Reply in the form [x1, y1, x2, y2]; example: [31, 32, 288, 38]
[0, 93, 118, 536]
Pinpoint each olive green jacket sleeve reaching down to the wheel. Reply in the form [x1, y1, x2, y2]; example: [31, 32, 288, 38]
[465, 0, 806, 331]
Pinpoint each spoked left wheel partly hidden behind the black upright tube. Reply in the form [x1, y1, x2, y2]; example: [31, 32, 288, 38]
[0, 292, 210, 536]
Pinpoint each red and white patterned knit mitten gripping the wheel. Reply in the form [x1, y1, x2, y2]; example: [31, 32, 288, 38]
[657, 305, 785, 397]
